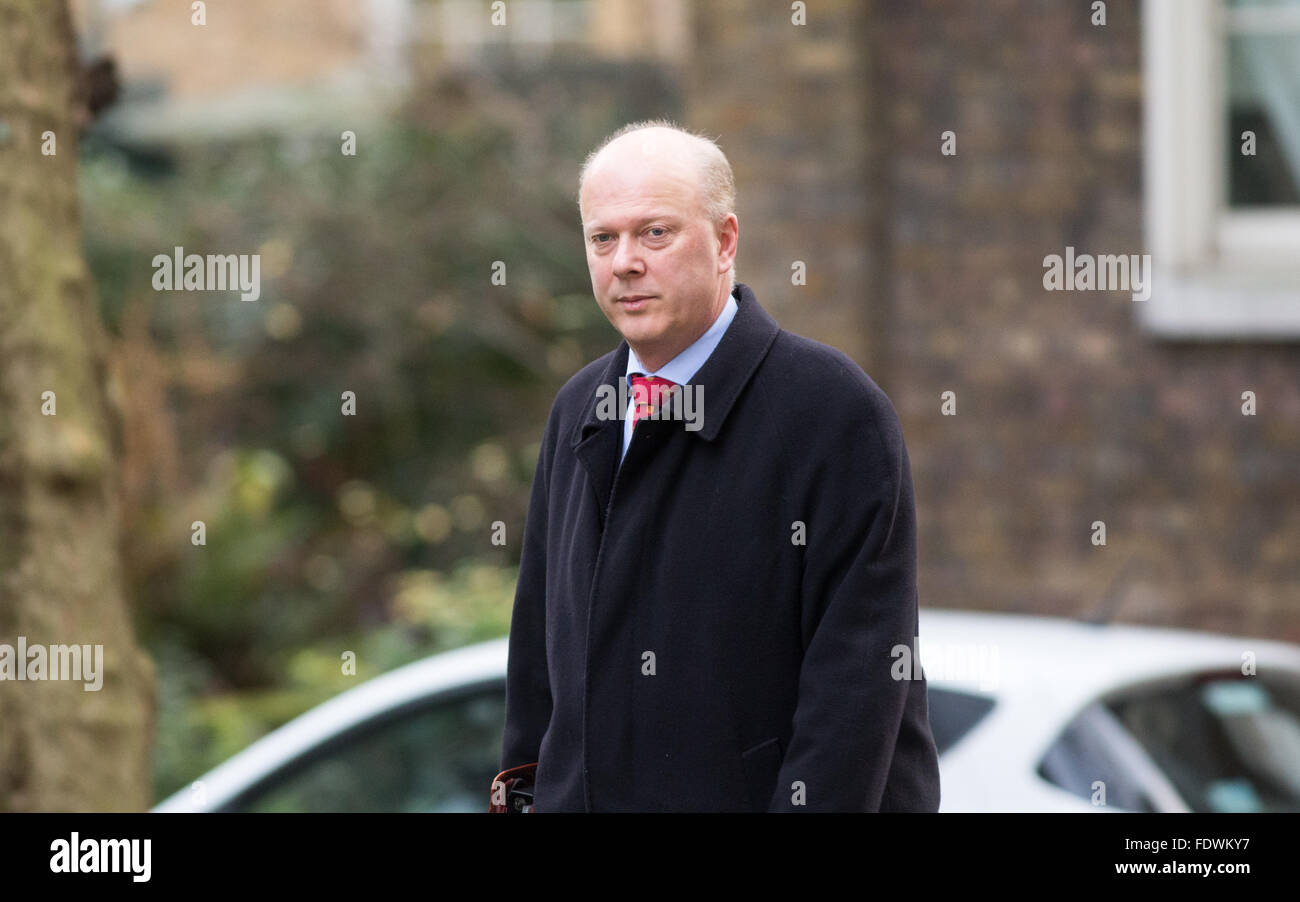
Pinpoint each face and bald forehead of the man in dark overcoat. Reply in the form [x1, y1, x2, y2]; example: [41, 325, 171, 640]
[581, 133, 737, 372]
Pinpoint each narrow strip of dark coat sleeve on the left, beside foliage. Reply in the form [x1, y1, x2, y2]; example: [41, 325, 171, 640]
[501, 407, 556, 771]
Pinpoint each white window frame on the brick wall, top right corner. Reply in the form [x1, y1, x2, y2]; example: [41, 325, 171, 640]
[1135, 0, 1300, 339]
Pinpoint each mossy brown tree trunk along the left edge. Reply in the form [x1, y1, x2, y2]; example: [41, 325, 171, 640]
[0, 0, 153, 811]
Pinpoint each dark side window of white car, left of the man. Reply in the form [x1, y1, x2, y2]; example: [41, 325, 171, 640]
[228, 682, 506, 812]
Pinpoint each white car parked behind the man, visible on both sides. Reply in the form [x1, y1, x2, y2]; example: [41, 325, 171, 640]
[153, 610, 1300, 812]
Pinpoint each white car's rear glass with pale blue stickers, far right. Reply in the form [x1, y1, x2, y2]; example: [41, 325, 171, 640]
[1110, 672, 1300, 811]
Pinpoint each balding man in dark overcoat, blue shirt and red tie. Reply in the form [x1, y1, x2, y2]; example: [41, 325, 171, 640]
[501, 121, 939, 812]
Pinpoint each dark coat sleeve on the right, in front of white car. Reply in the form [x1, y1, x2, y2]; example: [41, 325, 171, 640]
[768, 383, 939, 812]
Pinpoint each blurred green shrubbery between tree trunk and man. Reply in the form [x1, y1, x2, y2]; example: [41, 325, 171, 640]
[82, 68, 676, 798]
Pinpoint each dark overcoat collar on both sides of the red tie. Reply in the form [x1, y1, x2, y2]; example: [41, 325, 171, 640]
[569, 282, 781, 511]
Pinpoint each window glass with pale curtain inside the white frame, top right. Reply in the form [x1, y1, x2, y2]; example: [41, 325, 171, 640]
[1226, 0, 1300, 207]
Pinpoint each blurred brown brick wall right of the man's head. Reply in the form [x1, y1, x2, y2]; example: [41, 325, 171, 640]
[686, 0, 1300, 641]
